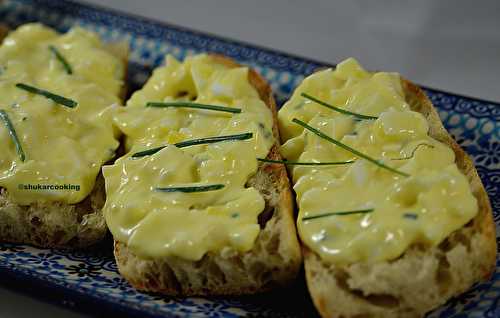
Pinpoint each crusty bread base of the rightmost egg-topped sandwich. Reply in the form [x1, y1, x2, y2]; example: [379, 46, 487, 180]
[303, 79, 496, 318]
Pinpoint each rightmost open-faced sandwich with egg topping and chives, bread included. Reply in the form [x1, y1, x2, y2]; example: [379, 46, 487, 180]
[278, 59, 496, 317]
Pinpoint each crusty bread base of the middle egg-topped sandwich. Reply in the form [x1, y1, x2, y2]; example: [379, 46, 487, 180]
[114, 55, 302, 296]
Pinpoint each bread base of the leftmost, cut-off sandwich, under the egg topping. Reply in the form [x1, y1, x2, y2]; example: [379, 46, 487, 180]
[0, 25, 129, 248]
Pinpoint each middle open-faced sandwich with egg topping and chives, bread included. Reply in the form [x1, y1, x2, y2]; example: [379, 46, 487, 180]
[103, 55, 301, 295]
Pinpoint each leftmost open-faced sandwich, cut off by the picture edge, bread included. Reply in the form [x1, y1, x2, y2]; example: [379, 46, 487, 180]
[0, 24, 128, 247]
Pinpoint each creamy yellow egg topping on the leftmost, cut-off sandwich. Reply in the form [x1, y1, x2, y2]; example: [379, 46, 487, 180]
[0, 24, 124, 204]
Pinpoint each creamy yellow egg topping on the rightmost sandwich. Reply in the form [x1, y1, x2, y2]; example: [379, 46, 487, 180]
[279, 59, 478, 264]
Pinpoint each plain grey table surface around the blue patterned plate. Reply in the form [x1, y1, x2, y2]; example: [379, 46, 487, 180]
[0, 0, 500, 318]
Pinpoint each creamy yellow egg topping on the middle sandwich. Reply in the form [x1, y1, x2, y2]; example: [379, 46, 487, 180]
[103, 55, 274, 260]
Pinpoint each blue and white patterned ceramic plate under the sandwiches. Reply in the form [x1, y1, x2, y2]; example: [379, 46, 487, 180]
[0, 0, 500, 317]
